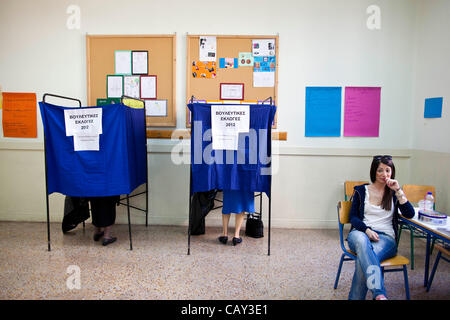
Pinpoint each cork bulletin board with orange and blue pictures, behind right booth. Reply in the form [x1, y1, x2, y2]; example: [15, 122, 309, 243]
[186, 35, 279, 128]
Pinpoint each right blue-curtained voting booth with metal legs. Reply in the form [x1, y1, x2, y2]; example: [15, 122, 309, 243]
[188, 99, 276, 255]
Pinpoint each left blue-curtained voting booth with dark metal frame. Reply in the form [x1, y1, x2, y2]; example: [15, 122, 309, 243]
[39, 94, 148, 251]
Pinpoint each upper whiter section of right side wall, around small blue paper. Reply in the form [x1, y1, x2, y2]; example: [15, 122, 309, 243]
[413, 0, 450, 153]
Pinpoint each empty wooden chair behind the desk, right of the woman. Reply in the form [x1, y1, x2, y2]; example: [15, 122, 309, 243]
[397, 184, 436, 270]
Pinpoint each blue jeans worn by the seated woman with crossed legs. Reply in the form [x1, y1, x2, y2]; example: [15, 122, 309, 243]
[347, 230, 397, 300]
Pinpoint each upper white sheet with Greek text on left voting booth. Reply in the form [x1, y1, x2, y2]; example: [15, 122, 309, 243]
[64, 108, 102, 136]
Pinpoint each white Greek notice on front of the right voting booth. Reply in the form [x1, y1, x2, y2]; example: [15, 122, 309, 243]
[211, 105, 250, 150]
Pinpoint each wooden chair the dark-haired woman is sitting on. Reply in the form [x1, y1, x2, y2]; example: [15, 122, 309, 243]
[334, 201, 410, 300]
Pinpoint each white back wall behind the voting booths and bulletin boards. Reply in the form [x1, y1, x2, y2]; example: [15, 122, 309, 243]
[0, 0, 450, 227]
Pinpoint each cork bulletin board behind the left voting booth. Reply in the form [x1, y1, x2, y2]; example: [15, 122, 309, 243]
[86, 34, 176, 127]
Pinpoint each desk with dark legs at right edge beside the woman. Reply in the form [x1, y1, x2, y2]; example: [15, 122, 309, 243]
[400, 208, 450, 287]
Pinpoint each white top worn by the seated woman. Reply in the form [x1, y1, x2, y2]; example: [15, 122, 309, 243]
[363, 185, 395, 239]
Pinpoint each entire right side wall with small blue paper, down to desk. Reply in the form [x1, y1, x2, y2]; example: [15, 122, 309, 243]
[410, 0, 450, 214]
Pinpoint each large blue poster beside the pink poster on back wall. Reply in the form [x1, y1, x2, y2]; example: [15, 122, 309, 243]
[305, 87, 342, 137]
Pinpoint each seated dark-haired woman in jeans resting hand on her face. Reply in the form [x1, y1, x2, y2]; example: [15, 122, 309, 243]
[347, 155, 414, 300]
